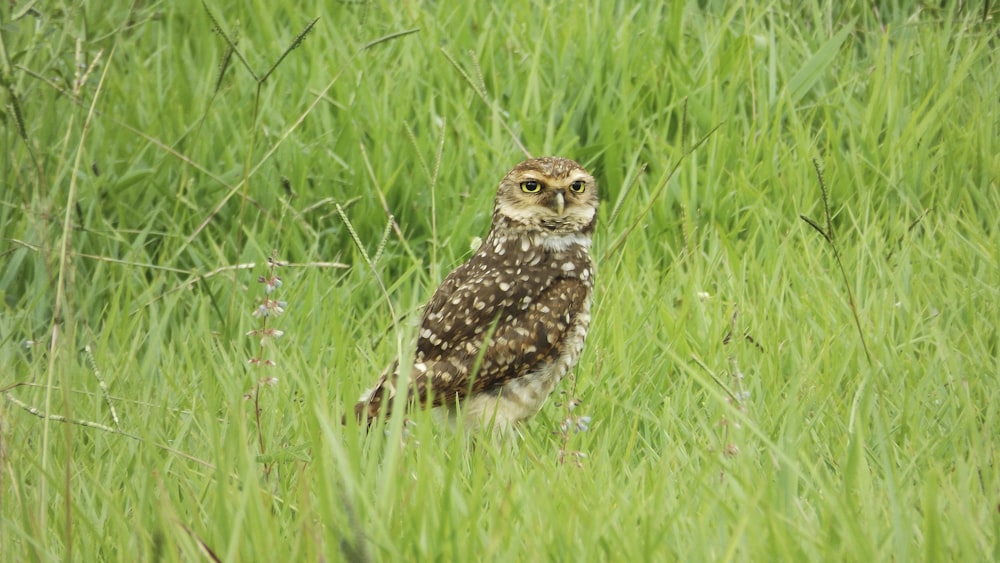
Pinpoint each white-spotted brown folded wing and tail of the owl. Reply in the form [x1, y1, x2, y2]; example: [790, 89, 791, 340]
[355, 259, 589, 420]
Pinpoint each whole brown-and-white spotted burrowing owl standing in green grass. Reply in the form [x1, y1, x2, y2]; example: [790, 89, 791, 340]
[355, 157, 598, 433]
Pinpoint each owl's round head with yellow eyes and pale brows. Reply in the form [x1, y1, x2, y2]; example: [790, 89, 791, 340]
[493, 157, 598, 235]
